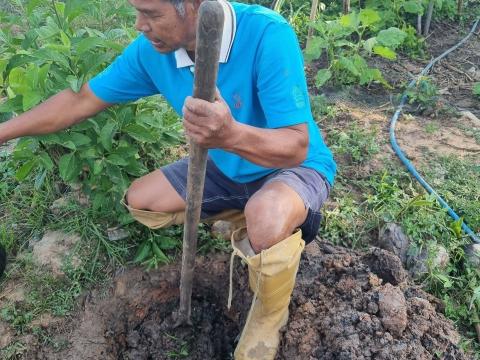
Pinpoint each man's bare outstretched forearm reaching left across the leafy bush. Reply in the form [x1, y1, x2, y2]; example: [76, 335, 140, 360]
[0, 85, 108, 144]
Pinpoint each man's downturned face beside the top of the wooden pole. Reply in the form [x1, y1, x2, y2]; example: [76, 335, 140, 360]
[128, 0, 198, 53]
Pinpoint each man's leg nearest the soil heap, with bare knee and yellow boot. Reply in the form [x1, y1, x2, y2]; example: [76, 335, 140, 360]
[232, 168, 329, 360]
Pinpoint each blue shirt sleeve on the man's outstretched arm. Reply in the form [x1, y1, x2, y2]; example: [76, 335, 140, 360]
[89, 36, 158, 104]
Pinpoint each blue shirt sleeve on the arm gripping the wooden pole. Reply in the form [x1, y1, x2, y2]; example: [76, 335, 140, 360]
[256, 22, 312, 128]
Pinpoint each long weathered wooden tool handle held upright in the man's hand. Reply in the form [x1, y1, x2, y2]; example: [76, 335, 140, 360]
[176, 1, 224, 326]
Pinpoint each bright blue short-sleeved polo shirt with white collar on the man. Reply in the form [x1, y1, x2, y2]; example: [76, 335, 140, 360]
[89, 1, 336, 185]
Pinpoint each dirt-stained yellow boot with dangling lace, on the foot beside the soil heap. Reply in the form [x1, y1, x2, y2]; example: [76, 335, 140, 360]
[229, 229, 305, 360]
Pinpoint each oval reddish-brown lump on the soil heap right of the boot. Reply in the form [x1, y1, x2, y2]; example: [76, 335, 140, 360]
[378, 284, 408, 337]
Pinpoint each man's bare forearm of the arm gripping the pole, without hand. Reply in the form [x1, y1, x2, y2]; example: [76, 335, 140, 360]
[225, 123, 308, 168]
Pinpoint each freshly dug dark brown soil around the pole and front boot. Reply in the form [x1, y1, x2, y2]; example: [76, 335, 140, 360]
[29, 243, 468, 359]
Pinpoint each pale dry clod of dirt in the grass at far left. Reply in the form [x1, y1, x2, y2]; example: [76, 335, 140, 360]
[32, 231, 80, 276]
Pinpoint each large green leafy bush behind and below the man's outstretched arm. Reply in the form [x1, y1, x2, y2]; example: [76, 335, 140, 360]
[0, 0, 182, 214]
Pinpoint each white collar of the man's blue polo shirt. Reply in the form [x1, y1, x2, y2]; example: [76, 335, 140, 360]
[175, 0, 237, 68]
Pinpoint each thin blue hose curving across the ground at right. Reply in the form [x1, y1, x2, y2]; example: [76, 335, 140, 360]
[390, 18, 480, 243]
